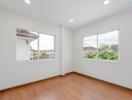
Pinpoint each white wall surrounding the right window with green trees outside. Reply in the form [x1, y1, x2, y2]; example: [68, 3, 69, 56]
[74, 12, 132, 89]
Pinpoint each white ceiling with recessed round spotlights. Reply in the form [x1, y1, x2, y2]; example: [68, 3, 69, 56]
[0, 0, 132, 29]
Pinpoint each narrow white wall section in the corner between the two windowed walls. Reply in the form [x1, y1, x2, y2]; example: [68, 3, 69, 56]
[61, 27, 73, 75]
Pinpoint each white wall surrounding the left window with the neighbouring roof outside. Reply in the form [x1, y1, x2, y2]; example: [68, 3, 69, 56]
[0, 10, 71, 90]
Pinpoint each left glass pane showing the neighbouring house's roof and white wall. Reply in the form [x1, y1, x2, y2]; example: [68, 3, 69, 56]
[16, 28, 38, 61]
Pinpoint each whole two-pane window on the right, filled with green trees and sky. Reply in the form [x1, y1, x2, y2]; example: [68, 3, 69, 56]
[83, 30, 119, 60]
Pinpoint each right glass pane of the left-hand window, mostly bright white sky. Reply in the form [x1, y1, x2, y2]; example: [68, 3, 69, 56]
[39, 34, 55, 59]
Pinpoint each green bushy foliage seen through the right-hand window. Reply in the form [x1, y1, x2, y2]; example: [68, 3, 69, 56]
[84, 44, 118, 60]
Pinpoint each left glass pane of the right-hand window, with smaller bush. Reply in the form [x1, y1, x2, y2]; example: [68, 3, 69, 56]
[83, 35, 97, 59]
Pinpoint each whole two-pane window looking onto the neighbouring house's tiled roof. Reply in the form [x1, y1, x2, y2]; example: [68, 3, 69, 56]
[16, 29, 55, 60]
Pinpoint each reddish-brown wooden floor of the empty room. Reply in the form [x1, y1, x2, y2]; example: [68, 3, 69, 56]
[0, 74, 132, 100]
